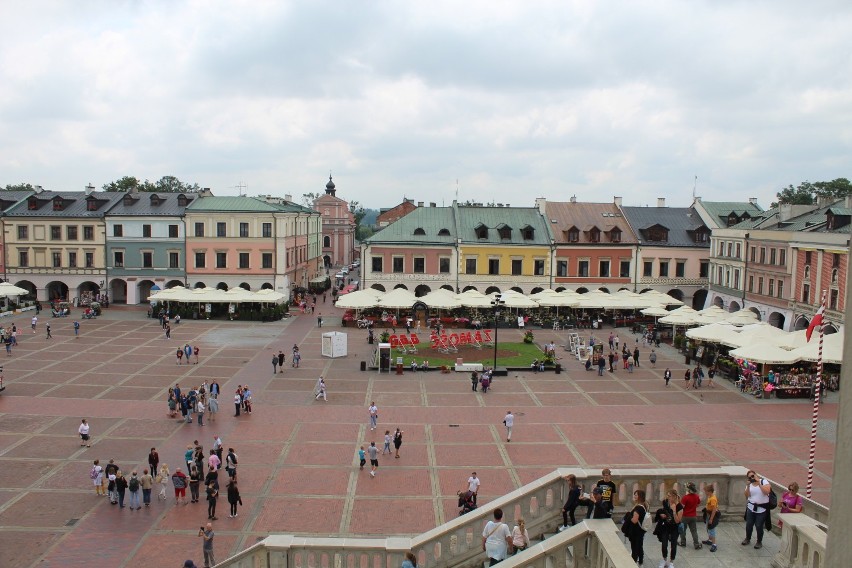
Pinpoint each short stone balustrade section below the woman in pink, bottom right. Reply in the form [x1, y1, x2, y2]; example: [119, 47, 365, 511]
[771, 513, 828, 568]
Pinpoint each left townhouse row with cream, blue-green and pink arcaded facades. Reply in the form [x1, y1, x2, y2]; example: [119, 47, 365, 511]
[0, 186, 326, 304]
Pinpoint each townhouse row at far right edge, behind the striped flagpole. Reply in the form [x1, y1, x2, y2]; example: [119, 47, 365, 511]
[709, 197, 852, 331]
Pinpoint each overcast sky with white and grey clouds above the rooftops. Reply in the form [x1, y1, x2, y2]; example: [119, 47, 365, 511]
[0, 0, 852, 208]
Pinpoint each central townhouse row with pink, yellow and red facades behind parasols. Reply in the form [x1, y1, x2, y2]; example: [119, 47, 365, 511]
[361, 197, 762, 308]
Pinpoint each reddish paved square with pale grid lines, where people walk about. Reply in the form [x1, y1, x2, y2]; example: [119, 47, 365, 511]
[0, 304, 837, 568]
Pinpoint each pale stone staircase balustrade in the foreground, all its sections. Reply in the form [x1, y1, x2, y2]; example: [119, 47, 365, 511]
[220, 466, 828, 568]
